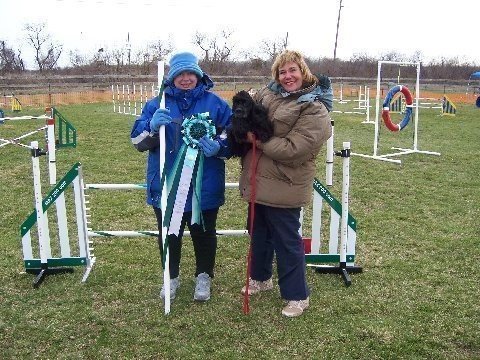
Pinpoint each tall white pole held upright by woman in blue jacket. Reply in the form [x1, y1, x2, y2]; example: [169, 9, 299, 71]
[158, 61, 170, 314]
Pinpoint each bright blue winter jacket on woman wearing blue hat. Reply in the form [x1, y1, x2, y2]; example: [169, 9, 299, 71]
[130, 74, 232, 212]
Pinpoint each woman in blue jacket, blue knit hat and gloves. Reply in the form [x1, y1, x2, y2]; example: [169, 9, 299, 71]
[130, 52, 231, 301]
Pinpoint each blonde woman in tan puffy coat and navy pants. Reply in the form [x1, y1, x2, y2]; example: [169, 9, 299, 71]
[240, 50, 332, 317]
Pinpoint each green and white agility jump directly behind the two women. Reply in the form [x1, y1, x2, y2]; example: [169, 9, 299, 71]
[20, 143, 362, 287]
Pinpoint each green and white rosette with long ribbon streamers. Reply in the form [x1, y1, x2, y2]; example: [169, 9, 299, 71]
[164, 112, 215, 236]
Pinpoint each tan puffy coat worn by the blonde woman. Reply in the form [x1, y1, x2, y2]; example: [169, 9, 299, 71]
[239, 84, 332, 208]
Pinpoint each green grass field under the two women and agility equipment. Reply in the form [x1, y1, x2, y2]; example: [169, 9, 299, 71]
[0, 100, 480, 359]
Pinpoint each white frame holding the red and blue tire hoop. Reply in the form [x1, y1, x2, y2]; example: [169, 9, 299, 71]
[352, 61, 440, 164]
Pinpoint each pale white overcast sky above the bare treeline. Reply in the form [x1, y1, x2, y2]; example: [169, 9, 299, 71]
[0, 0, 480, 67]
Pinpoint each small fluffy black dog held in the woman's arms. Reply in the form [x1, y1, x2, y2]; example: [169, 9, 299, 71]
[227, 90, 273, 157]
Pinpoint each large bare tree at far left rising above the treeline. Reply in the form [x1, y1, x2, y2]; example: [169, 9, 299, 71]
[24, 23, 63, 72]
